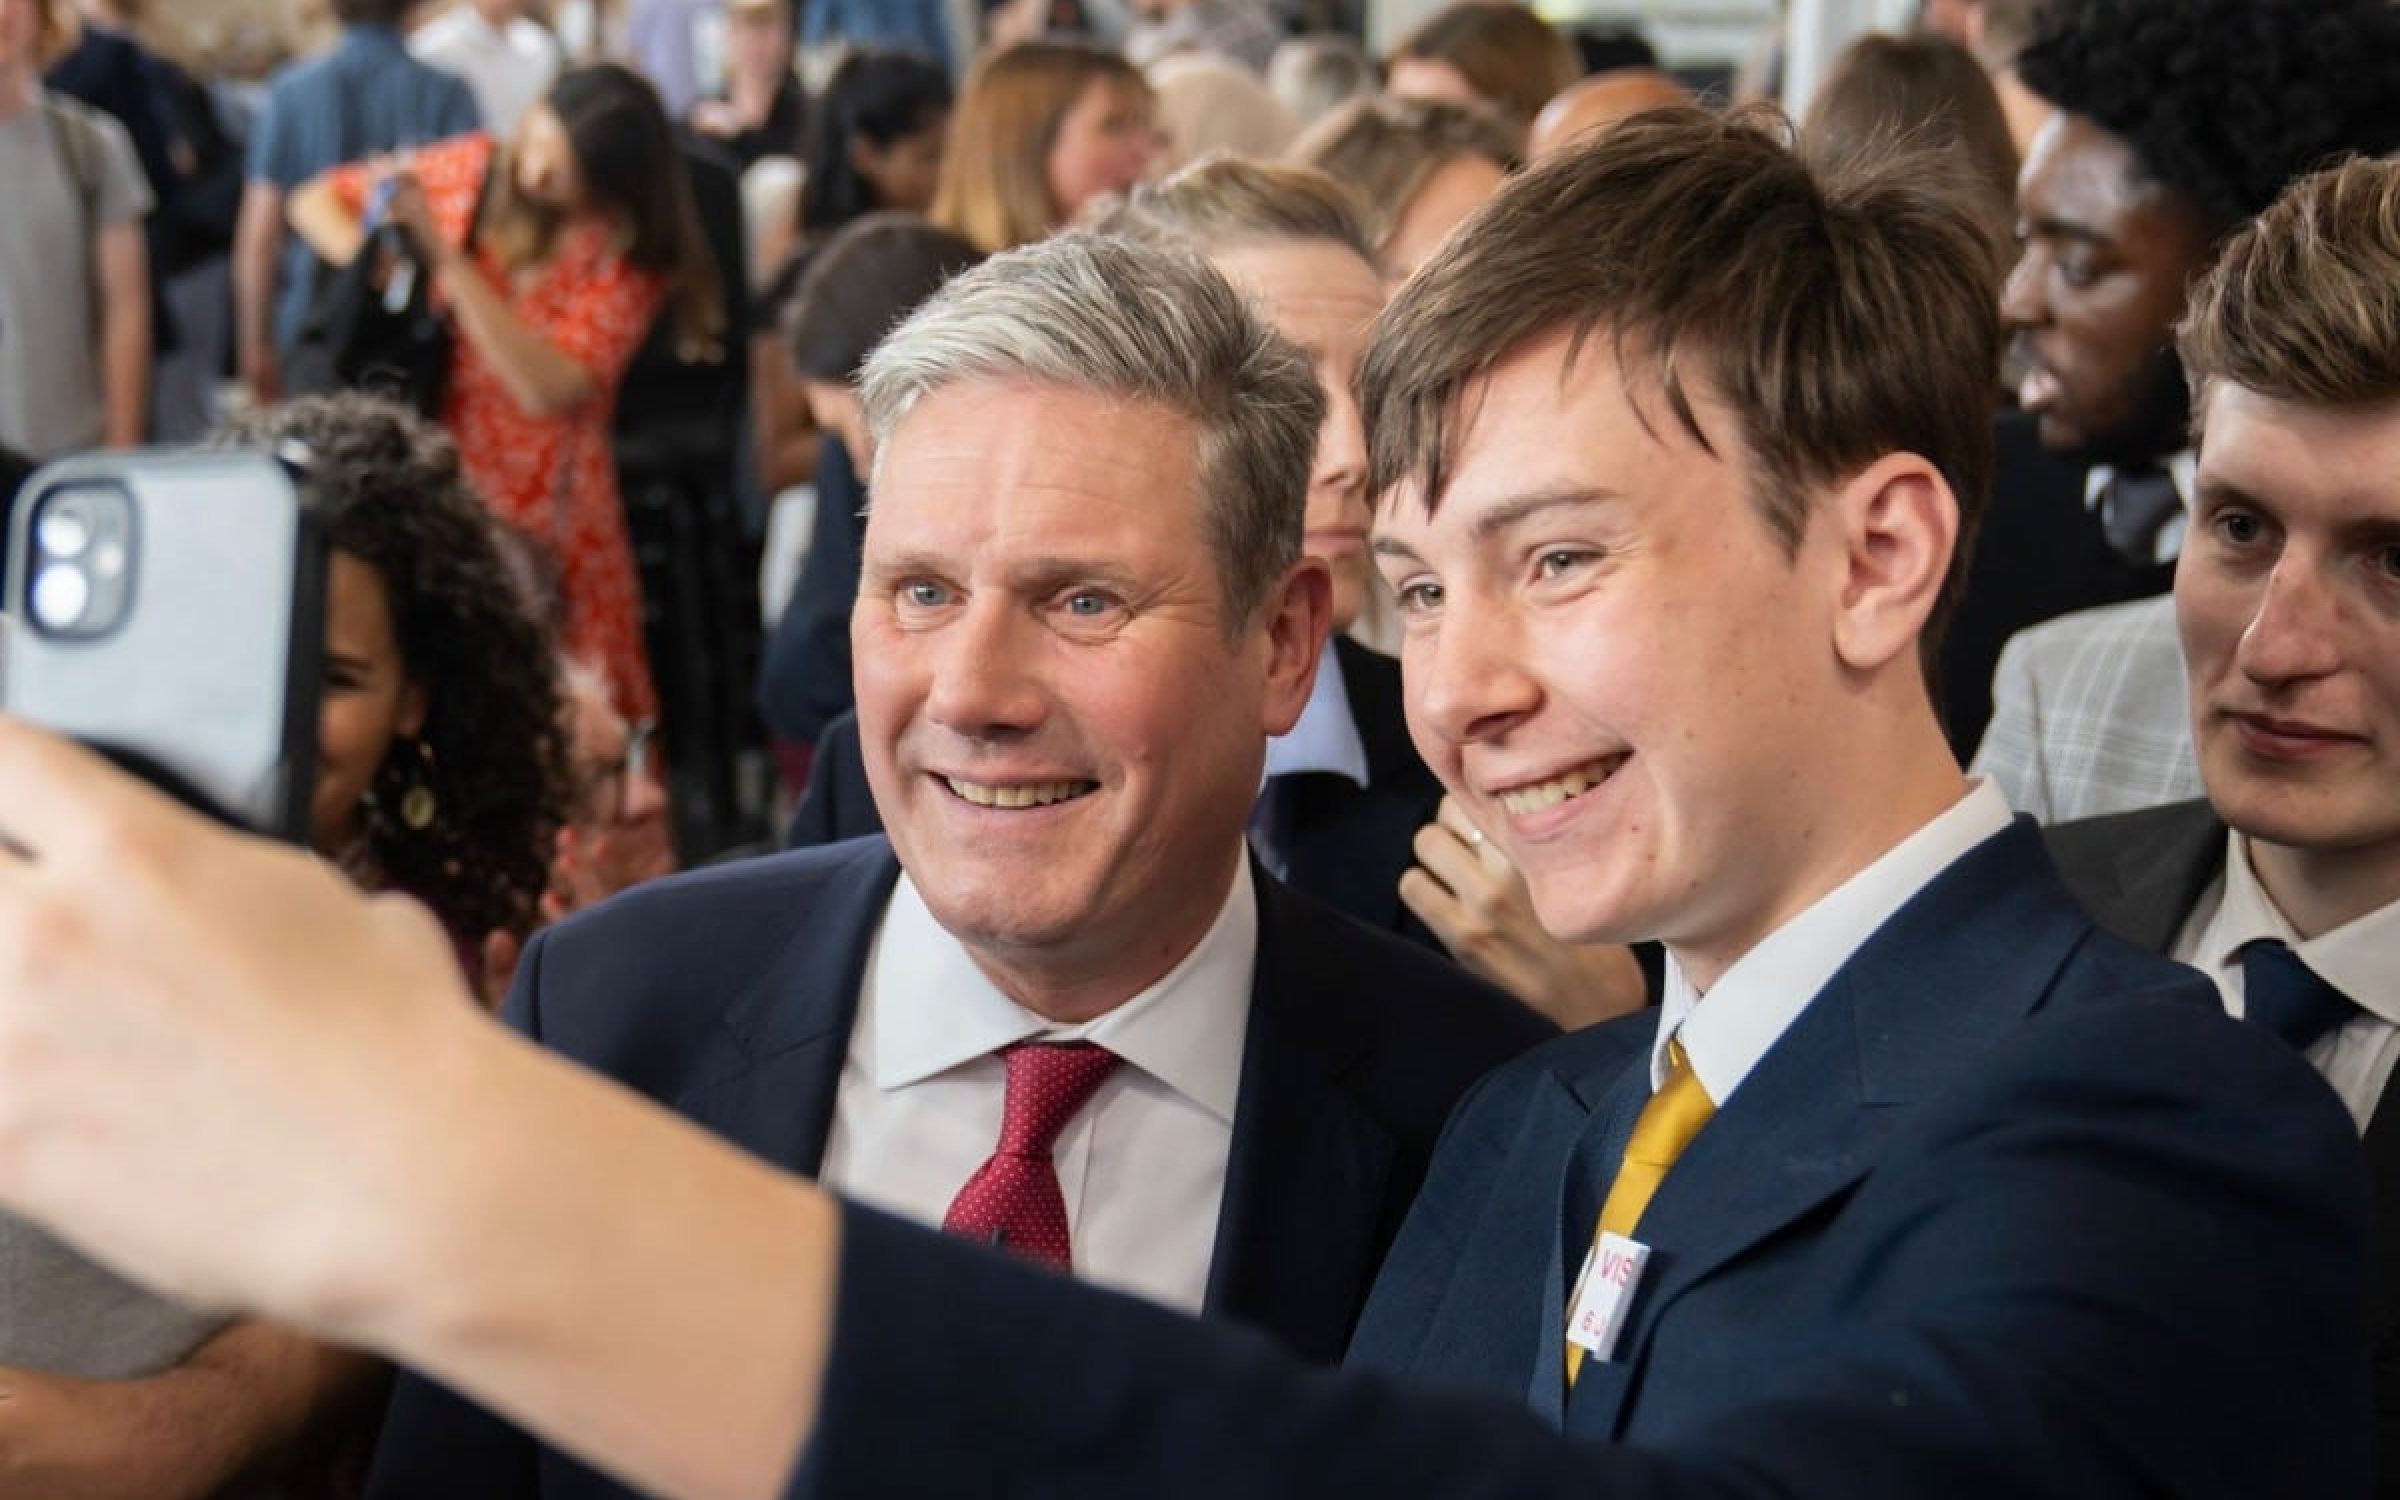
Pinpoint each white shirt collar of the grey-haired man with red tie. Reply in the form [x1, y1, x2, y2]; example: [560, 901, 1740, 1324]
[857, 859, 1258, 1123]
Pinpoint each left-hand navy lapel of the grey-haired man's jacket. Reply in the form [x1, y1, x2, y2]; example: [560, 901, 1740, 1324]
[674, 840, 900, 1176]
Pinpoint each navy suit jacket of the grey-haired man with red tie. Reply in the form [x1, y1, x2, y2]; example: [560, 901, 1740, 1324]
[370, 838, 1558, 1500]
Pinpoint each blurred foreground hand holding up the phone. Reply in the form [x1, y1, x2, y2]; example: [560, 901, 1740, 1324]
[0, 718, 490, 1315]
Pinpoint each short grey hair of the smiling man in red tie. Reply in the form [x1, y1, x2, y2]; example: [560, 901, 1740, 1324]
[859, 233, 1325, 634]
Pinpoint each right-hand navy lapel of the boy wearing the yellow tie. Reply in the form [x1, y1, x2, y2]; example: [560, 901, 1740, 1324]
[1567, 818, 2088, 1438]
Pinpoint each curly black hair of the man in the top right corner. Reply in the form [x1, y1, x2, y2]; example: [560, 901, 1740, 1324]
[2016, 0, 2400, 230]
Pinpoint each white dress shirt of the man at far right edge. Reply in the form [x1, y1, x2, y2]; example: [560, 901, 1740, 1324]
[2174, 833, 2400, 1133]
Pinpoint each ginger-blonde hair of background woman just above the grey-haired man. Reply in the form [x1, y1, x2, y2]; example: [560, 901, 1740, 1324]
[929, 41, 1150, 252]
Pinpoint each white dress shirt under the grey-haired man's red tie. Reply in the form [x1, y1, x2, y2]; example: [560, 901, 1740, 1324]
[818, 859, 1258, 1313]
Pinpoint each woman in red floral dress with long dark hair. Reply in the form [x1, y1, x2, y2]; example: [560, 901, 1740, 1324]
[290, 65, 722, 718]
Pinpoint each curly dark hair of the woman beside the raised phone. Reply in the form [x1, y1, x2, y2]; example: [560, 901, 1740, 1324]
[216, 391, 569, 941]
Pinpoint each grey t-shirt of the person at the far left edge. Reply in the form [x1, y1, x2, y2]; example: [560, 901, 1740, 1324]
[0, 103, 151, 458]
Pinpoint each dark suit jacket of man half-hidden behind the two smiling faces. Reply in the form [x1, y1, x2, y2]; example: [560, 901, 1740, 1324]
[787, 636, 1442, 953]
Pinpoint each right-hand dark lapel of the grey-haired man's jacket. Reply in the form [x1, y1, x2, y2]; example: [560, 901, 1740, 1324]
[1202, 866, 1399, 1363]
